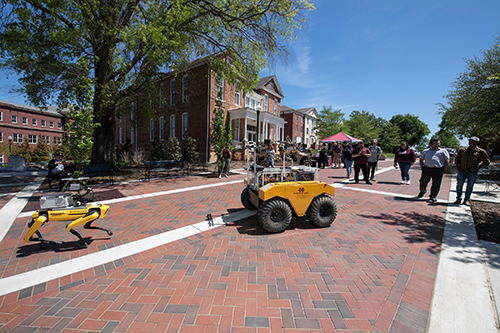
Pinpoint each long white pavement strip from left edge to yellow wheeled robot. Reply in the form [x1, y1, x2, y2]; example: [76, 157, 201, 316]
[0, 209, 256, 296]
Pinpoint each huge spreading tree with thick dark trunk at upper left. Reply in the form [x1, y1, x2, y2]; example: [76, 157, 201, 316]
[0, 0, 314, 164]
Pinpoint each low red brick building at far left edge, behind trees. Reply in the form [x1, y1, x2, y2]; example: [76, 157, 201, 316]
[0, 101, 66, 163]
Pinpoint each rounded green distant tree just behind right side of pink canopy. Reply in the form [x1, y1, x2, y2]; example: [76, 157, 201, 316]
[344, 111, 383, 142]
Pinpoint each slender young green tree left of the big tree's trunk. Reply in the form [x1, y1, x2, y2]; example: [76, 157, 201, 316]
[66, 58, 99, 170]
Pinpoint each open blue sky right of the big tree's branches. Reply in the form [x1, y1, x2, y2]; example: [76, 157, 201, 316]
[262, 0, 500, 145]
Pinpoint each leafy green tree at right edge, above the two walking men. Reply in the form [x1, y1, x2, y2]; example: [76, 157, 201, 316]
[438, 37, 500, 141]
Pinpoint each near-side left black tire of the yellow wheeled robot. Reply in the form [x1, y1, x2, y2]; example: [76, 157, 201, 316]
[257, 198, 292, 234]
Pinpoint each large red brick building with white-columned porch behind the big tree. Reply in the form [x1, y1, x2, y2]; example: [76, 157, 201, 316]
[115, 59, 285, 161]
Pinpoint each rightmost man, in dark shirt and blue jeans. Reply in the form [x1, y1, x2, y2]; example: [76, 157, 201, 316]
[454, 136, 490, 206]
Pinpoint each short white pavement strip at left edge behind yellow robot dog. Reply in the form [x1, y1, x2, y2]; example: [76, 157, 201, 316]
[0, 177, 45, 242]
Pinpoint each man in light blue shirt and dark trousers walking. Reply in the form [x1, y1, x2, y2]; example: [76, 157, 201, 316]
[418, 138, 450, 202]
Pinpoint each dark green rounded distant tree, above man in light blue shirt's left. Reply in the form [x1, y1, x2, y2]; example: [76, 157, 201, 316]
[389, 113, 431, 146]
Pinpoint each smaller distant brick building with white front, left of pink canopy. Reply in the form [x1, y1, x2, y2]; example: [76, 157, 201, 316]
[281, 105, 319, 148]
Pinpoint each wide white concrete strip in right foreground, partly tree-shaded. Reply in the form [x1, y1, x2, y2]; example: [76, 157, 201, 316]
[428, 177, 498, 333]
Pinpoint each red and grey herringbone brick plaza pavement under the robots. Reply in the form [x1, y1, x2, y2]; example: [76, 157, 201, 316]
[0, 161, 451, 333]
